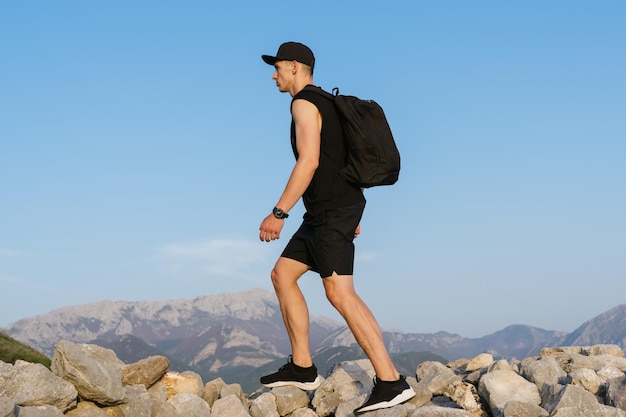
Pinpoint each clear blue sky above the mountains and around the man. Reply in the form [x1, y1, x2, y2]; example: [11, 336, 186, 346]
[0, 1, 626, 337]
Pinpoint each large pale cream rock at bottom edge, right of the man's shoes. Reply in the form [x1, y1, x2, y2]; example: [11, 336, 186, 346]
[478, 370, 541, 415]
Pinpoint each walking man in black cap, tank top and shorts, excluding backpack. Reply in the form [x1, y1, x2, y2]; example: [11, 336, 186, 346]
[259, 42, 415, 413]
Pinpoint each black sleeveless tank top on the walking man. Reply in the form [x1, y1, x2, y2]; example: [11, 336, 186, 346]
[291, 85, 365, 215]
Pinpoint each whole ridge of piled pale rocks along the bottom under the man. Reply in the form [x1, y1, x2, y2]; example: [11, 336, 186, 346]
[0, 341, 626, 417]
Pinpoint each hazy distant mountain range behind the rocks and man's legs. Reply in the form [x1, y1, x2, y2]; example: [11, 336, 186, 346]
[3, 289, 626, 392]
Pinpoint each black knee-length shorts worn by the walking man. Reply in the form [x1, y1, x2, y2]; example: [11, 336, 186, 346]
[281, 202, 365, 278]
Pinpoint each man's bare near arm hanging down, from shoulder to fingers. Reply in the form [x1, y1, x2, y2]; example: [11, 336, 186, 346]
[259, 100, 322, 242]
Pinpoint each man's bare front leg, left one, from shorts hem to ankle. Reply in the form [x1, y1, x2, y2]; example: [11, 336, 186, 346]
[272, 257, 313, 368]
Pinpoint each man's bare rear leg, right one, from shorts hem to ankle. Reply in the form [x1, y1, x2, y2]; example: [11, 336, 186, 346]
[322, 274, 400, 381]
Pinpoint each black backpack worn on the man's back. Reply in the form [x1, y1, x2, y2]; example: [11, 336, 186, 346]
[316, 88, 400, 188]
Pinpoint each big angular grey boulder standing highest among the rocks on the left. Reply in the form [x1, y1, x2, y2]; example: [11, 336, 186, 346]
[52, 341, 125, 406]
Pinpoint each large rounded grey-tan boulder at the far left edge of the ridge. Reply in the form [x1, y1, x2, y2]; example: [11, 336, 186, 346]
[0, 362, 78, 412]
